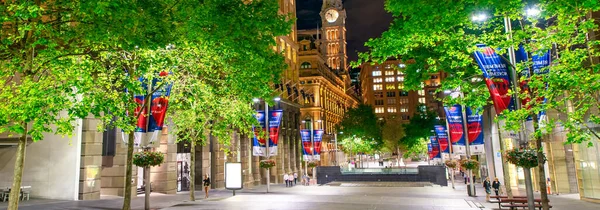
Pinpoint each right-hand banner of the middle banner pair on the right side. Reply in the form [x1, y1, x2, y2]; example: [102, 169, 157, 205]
[466, 107, 485, 155]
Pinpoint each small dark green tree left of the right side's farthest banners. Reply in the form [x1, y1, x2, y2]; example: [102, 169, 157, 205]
[400, 104, 438, 152]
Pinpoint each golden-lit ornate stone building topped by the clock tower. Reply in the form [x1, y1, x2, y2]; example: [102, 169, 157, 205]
[298, 0, 360, 165]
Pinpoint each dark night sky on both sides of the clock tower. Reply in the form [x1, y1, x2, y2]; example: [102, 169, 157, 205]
[296, 0, 392, 61]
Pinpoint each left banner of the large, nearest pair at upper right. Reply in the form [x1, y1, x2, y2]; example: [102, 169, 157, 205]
[475, 44, 515, 114]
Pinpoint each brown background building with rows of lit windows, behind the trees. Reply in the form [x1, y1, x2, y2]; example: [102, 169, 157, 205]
[360, 60, 444, 123]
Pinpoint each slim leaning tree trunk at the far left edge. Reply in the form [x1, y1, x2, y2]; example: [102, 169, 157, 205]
[8, 123, 27, 210]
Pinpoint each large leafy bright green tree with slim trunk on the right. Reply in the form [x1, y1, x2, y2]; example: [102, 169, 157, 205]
[360, 0, 600, 209]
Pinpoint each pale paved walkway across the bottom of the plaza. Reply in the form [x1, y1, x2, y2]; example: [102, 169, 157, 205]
[0, 182, 600, 210]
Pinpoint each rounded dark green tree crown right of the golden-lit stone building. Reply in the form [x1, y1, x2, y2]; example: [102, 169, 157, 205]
[336, 104, 383, 153]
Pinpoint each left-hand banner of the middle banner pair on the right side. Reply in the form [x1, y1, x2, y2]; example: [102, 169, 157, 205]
[444, 104, 467, 155]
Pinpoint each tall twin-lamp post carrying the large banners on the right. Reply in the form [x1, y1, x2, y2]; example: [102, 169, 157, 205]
[473, 7, 543, 210]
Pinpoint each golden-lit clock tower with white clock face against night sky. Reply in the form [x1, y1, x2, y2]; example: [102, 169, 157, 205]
[320, 0, 348, 73]
